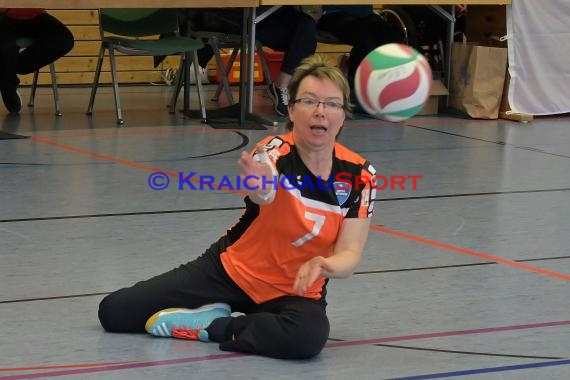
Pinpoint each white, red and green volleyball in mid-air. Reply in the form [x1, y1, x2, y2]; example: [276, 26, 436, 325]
[354, 43, 432, 122]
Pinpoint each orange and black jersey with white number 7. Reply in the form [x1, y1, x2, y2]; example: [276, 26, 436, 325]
[217, 133, 375, 303]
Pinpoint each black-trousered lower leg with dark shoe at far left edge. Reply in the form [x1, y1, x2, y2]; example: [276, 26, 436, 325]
[0, 16, 22, 113]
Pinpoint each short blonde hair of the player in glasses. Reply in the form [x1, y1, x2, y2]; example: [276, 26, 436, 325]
[286, 54, 352, 129]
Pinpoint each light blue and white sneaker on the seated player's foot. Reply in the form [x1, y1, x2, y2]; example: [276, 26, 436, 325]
[145, 303, 231, 342]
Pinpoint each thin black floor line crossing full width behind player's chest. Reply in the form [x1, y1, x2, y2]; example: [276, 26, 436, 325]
[0, 188, 570, 223]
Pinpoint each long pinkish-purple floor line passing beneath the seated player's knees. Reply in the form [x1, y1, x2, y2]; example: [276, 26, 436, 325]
[0, 320, 570, 380]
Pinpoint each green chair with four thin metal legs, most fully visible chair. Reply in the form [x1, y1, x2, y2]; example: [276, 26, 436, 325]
[87, 8, 206, 125]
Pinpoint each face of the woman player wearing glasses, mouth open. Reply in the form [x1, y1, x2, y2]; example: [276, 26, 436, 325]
[289, 76, 346, 150]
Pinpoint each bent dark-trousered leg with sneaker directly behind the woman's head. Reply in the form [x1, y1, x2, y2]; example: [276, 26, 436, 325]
[256, 6, 317, 116]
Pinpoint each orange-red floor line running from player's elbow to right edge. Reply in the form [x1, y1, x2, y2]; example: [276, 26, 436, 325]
[370, 226, 570, 281]
